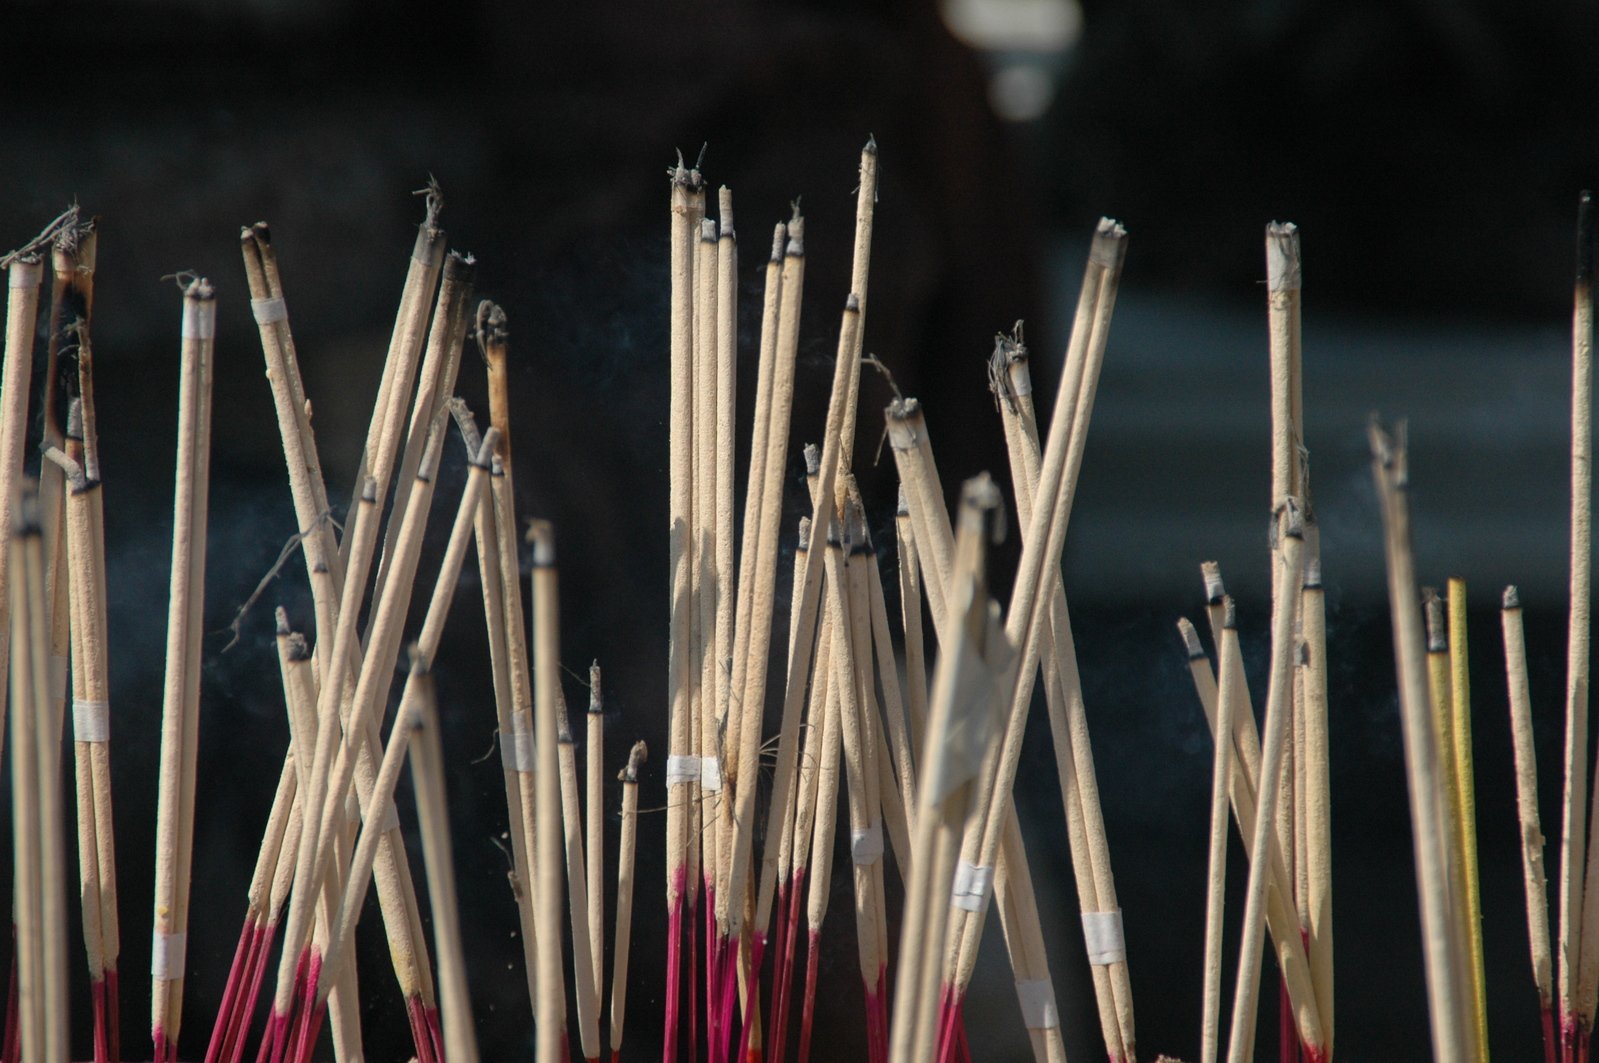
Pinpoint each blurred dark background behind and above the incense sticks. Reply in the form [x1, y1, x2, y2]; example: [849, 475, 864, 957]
[0, 0, 1599, 1060]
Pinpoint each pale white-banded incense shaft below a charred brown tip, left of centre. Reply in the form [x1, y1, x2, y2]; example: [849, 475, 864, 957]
[477, 459, 539, 1007]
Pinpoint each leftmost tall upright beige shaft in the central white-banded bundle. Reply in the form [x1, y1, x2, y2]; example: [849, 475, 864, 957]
[668, 158, 702, 914]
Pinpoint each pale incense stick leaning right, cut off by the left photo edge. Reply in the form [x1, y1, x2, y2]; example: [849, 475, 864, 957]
[0, 254, 43, 754]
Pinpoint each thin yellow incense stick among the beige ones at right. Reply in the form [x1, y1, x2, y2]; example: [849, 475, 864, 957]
[1447, 577, 1489, 1063]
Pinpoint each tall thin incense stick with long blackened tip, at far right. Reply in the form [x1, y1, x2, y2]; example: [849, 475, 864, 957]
[1556, 190, 1594, 1060]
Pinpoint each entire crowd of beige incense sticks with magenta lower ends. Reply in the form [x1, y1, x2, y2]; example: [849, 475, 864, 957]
[9, 141, 1599, 1063]
